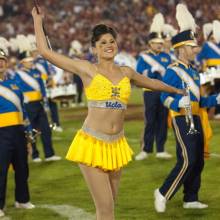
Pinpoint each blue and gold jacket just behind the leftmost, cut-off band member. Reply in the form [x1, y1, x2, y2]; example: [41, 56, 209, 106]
[13, 68, 46, 103]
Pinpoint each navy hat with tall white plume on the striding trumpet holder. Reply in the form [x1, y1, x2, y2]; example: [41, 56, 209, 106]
[171, 4, 198, 48]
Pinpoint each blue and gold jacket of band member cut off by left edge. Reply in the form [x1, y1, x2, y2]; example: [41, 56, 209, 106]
[0, 79, 32, 131]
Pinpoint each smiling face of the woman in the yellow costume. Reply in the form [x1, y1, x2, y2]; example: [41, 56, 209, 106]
[93, 33, 118, 60]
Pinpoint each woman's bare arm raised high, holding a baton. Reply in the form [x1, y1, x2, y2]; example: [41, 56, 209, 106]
[32, 7, 94, 76]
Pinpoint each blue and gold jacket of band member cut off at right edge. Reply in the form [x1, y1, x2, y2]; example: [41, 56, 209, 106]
[196, 41, 220, 70]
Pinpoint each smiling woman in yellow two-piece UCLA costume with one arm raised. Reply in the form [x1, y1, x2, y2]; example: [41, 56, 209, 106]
[32, 8, 182, 220]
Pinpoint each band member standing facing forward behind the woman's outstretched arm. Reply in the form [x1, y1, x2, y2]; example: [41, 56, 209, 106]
[135, 13, 171, 160]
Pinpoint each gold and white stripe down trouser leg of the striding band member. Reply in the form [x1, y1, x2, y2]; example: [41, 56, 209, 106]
[165, 118, 189, 200]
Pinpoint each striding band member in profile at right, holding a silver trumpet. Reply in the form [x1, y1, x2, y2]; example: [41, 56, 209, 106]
[154, 4, 220, 212]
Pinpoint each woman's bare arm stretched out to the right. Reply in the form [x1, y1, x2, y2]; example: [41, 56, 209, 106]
[125, 67, 184, 94]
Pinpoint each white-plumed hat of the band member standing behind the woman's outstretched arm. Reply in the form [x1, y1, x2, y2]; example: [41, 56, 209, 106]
[148, 13, 165, 43]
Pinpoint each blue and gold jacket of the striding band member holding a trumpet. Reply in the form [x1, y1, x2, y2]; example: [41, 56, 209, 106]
[161, 60, 217, 117]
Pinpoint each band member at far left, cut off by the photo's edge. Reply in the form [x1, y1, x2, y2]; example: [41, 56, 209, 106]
[0, 40, 35, 217]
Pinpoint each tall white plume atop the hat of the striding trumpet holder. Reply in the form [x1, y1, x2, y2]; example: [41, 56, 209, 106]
[176, 4, 197, 33]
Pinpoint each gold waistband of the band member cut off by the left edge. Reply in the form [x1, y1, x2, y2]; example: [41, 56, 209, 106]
[0, 112, 23, 127]
